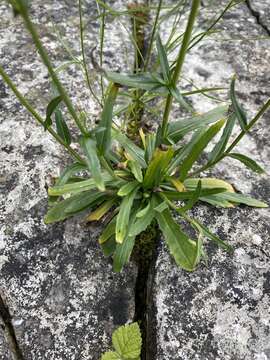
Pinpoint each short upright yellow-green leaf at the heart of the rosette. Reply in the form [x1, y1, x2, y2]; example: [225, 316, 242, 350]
[143, 147, 174, 189]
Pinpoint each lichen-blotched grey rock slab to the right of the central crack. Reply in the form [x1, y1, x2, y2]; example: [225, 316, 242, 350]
[152, 1, 270, 360]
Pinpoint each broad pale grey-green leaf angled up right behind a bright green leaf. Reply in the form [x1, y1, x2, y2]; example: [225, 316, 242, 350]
[168, 106, 228, 143]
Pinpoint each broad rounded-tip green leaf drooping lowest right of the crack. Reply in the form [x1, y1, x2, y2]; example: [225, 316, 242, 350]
[156, 209, 198, 271]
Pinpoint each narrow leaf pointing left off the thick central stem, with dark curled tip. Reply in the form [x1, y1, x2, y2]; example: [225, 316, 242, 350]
[106, 71, 161, 91]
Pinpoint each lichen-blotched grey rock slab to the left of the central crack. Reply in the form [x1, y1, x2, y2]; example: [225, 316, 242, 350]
[0, 1, 137, 360]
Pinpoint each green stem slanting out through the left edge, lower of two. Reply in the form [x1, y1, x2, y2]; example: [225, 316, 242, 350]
[0, 65, 84, 163]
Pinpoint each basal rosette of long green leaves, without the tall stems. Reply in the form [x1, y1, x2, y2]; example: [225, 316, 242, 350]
[45, 78, 267, 272]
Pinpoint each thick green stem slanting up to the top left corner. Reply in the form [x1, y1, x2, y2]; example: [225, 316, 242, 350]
[18, 0, 87, 135]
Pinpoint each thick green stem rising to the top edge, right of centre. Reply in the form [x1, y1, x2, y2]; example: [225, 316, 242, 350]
[161, 0, 200, 139]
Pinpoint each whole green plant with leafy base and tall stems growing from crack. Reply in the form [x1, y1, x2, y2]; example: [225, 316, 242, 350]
[0, 0, 270, 272]
